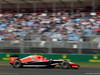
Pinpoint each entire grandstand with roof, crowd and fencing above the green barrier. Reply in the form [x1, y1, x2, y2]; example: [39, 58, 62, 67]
[0, 0, 100, 54]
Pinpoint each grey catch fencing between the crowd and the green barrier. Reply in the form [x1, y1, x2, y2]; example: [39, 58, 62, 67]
[0, 35, 100, 54]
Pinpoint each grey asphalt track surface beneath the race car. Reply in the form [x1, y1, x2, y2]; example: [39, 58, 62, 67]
[0, 65, 100, 75]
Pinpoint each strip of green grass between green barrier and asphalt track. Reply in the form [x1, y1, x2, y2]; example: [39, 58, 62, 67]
[0, 60, 100, 67]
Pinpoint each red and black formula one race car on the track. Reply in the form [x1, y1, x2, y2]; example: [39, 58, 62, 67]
[10, 55, 79, 69]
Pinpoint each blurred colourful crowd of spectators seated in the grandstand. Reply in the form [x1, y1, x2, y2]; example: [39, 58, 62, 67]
[0, 12, 100, 41]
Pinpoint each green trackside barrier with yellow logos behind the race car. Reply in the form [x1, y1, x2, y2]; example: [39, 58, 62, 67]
[0, 54, 100, 62]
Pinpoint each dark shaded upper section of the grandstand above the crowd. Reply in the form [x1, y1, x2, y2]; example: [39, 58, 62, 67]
[0, 0, 100, 13]
